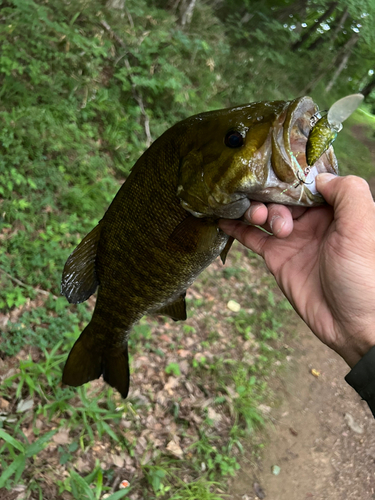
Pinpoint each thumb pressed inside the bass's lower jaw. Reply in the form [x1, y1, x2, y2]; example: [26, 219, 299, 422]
[316, 173, 374, 220]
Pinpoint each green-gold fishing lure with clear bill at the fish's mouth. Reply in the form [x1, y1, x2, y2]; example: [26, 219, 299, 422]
[306, 94, 364, 166]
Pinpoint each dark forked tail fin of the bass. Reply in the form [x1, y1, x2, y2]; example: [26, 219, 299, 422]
[62, 323, 130, 398]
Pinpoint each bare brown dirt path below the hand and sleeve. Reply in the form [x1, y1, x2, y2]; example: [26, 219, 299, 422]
[232, 322, 375, 500]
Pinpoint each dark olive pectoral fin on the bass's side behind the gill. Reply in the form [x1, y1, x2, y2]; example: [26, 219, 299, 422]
[167, 215, 219, 253]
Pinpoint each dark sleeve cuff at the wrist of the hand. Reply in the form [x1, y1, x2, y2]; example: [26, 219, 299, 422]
[345, 346, 375, 417]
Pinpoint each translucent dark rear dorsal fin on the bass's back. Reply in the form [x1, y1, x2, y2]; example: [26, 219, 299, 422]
[61, 224, 101, 304]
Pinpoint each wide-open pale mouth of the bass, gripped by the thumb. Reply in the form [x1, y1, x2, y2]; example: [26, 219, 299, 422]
[262, 97, 338, 206]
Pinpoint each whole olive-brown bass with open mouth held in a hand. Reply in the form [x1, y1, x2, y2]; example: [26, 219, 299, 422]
[61, 96, 338, 398]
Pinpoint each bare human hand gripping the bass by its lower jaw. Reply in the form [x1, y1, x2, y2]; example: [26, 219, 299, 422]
[219, 174, 375, 367]
